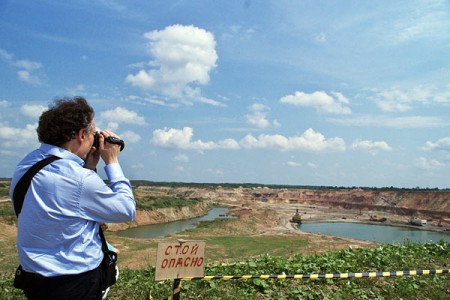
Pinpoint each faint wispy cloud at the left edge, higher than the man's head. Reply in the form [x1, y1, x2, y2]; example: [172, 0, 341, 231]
[0, 48, 43, 85]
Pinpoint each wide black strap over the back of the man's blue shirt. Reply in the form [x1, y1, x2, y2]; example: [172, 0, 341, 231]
[13, 156, 61, 217]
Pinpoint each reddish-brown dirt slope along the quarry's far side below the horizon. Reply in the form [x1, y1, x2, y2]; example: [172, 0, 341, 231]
[185, 188, 450, 218]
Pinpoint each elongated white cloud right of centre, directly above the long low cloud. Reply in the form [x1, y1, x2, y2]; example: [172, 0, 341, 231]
[280, 91, 351, 114]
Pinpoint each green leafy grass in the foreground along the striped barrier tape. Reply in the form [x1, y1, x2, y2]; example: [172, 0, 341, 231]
[0, 239, 450, 300]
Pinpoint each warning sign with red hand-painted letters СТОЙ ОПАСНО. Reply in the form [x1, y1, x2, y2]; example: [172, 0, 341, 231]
[155, 240, 206, 281]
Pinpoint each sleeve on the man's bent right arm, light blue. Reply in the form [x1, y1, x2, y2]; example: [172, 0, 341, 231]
[79, 163, 136, 223]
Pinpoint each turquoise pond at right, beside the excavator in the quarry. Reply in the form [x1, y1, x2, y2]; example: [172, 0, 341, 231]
[299, 222, 450, 243]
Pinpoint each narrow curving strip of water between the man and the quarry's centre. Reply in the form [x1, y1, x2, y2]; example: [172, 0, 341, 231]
[117, 207, 234, 238]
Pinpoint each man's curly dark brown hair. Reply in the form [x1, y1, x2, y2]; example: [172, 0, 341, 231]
[36, 97, 94, 147]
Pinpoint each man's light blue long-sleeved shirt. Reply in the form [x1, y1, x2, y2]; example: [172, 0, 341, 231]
[10, 144, 136, 276]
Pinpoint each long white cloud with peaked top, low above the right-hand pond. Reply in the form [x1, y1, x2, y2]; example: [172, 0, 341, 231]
[239, 128, 345, 152]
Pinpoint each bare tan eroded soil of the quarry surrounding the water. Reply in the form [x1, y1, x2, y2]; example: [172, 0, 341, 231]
[0, 188, 450, 272]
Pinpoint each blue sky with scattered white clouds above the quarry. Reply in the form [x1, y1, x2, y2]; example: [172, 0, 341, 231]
[0, 0, 450, 188]
